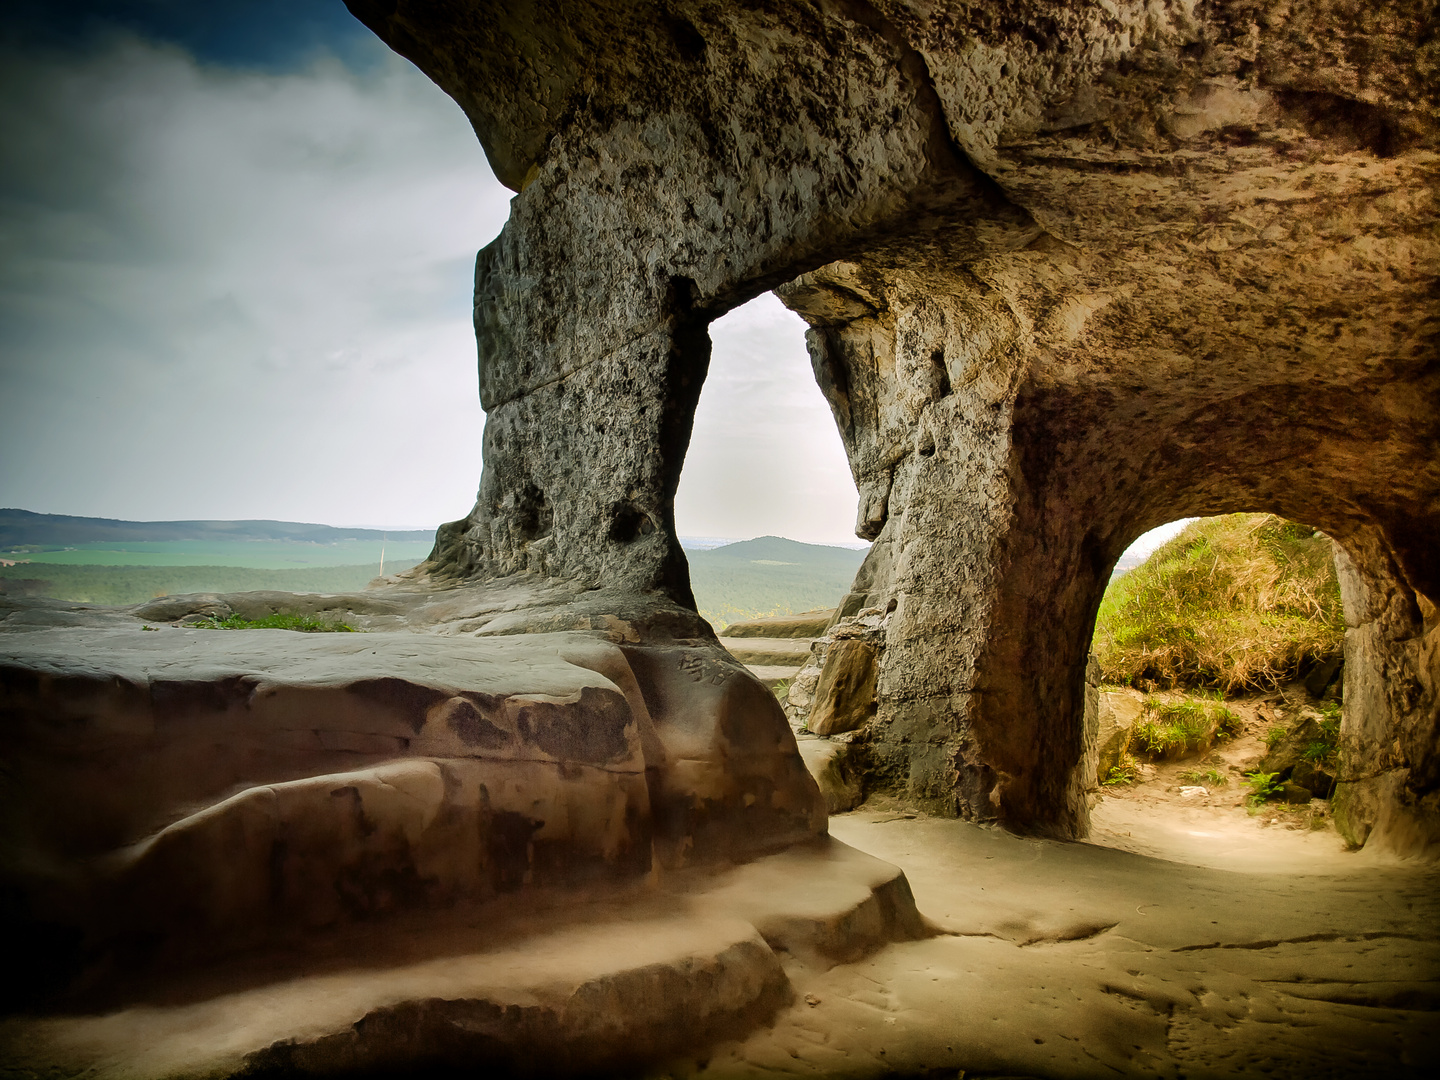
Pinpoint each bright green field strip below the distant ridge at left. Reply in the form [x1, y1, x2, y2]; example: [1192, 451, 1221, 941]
[7, 539, 435, 577]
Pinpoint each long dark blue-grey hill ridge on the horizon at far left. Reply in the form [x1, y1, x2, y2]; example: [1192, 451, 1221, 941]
[0, 508, 435, 550]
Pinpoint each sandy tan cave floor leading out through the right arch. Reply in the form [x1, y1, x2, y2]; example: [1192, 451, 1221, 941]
[652, 708, 1440, 1080]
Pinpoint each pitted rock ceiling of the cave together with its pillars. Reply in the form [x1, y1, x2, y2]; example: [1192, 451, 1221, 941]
[351, 0, 1440, 852]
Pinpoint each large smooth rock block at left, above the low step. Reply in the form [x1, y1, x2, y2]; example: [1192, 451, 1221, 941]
[0, 588, 825, 1001]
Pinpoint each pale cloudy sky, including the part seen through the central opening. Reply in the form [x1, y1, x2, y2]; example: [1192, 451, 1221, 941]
[0, 0, 855, 543]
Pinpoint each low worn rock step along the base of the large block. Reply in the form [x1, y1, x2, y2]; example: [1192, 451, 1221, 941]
[0, 838, 926, 1080]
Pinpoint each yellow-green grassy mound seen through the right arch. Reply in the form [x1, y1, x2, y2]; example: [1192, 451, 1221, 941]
[1094, 514, 1345, 693]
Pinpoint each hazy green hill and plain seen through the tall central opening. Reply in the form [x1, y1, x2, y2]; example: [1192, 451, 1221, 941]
[685, 536, 868, 626]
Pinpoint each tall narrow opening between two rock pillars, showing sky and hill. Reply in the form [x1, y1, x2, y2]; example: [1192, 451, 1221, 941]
[675, 294, 868, 633]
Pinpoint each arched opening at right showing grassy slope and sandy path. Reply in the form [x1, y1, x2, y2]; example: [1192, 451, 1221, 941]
[1084, 514, 1345, 863]
